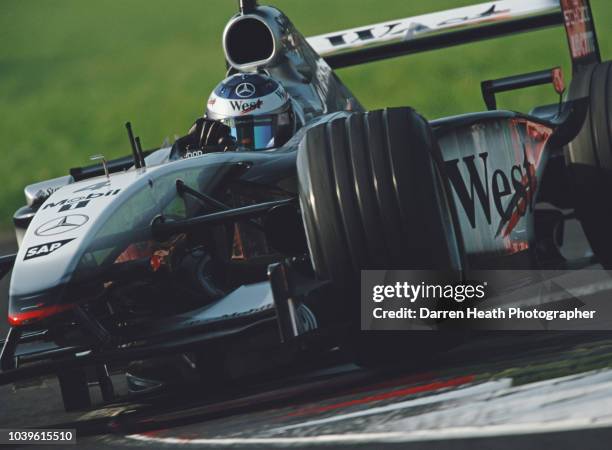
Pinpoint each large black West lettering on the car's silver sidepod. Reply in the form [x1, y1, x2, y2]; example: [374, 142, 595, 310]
[445, 149, 536, 235]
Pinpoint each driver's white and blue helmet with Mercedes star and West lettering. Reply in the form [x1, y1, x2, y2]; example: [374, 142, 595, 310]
[206, 73, 296, 150]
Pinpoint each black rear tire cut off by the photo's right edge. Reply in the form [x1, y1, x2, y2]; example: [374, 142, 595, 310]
[566, 61, 612, 268]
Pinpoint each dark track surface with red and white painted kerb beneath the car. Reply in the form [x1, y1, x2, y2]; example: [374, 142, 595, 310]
[0, 223, 612, 450]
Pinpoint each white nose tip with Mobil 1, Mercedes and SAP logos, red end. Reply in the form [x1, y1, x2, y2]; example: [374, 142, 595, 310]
[9, 176, 131, 326]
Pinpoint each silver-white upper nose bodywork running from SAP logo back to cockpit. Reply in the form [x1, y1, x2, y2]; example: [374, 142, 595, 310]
[10, 149, 272, 303]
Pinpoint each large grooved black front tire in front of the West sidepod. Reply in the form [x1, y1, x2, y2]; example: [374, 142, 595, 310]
[297, 108, 463, 366]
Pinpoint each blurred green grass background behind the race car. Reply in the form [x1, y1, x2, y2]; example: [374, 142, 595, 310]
[0, 0, 612, 229]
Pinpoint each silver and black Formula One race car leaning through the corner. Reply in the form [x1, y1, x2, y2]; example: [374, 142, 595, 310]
[0, 0, 612, 409]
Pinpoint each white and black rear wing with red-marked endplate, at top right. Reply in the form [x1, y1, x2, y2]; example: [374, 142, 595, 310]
[307, 0, 601, 71]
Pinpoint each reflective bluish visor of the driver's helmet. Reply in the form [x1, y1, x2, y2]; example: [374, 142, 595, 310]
[221, 111, 293, 150]
